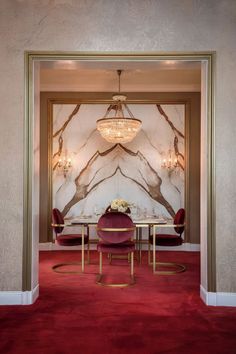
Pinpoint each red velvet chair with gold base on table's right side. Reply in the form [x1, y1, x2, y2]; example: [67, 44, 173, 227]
[148, 208, 186, 275]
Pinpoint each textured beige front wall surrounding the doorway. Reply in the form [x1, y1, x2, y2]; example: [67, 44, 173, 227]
[0, 0, 236, 292]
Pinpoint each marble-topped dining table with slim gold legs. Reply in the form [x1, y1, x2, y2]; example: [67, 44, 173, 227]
[65, 215, 183, 274]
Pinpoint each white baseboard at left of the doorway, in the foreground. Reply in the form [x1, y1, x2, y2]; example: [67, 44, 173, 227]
[0, 285, 39, 305]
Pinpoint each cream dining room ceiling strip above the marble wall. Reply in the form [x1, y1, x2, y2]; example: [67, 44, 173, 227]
[40, 60, 201, 92]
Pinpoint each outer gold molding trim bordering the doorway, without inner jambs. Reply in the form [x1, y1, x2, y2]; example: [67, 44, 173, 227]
[22, 51, 216, 292]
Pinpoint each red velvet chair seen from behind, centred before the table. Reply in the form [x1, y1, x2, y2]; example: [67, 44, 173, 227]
[97, 212, 135, 287]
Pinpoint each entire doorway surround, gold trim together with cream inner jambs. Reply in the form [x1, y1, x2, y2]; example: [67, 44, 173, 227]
[22, 52, 216, 300]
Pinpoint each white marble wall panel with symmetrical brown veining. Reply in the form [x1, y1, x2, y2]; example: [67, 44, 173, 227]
[52, 104, 185, 217]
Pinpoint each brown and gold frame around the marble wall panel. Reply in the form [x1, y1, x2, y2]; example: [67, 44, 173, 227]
[40, 92, 197, 243]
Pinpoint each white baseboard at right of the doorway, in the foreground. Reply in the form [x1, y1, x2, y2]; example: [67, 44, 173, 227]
[200, 285, 236, 307]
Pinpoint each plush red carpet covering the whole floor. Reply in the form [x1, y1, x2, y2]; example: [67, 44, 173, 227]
[0, 251, 236, 354]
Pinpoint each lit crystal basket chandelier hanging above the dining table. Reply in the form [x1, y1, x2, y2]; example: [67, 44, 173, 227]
[97, 70, 142, 144]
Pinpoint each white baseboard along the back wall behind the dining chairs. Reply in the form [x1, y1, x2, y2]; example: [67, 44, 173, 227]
[39, 242, 200, 252]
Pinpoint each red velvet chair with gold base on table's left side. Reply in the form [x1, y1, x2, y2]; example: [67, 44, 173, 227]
[52, 208, 89, 273]
